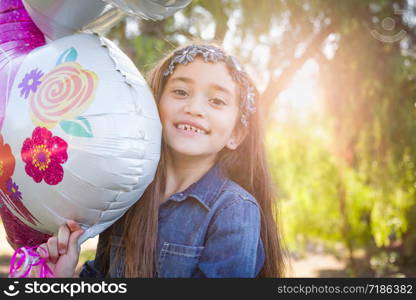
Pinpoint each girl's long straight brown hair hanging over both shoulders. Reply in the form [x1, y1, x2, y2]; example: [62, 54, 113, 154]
[102, 41, 285, 277]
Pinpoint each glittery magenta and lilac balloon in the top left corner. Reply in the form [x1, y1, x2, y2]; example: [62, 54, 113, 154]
[0, 0, 45, 132]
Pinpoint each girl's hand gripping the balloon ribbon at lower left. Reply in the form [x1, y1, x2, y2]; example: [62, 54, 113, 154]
[38, 220, 84, 278]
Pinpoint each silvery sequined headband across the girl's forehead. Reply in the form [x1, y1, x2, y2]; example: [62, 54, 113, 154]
[163, 45, 256, 127]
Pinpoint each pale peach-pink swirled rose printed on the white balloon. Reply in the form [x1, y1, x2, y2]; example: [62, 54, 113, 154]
[29, 62, 98, 129]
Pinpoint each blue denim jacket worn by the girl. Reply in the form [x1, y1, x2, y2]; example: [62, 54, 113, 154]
[80, 165, 264, 278]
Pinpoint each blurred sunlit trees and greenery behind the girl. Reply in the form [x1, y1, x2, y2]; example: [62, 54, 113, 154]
[0, 0, 416, 277]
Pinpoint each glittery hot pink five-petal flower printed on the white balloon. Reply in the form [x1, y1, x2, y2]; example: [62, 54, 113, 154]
[21, 127, 68, 185]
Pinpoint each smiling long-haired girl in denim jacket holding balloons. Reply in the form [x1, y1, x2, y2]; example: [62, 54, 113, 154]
[36, 44, 284, 277]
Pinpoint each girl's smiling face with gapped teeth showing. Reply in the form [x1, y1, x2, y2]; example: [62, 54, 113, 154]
[159, 57, 243, 158]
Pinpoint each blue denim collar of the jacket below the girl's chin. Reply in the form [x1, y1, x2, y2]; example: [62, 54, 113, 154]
[168, 164, 228, 210]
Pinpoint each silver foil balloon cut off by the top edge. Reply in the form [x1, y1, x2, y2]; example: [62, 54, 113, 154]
[23, 0, 192, 40]
